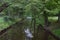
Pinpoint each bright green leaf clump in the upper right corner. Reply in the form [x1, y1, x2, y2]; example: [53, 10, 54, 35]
[46, 0, 60, 15]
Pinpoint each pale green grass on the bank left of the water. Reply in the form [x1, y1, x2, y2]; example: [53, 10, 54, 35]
[0, 17, 20, 30]
